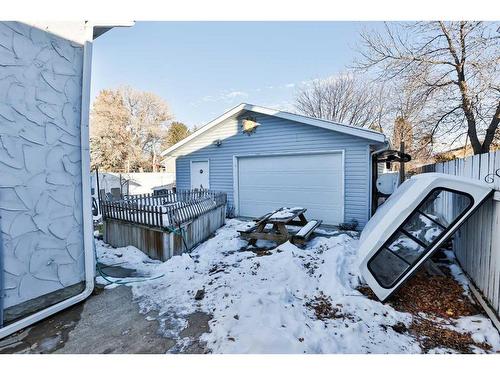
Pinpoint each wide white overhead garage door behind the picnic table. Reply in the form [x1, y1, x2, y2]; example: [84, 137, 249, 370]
[238, 152, 344, 224]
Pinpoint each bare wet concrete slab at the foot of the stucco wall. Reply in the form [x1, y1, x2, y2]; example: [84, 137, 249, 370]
[0, 284, 210, 354]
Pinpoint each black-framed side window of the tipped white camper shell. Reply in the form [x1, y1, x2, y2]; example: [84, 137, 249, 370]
[368, 188, 473, 288]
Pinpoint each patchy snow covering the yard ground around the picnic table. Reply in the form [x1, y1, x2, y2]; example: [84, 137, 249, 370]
[96, 219, 500, 353]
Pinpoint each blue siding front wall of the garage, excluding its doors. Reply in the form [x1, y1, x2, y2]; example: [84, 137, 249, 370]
[173, 113, 376, 226]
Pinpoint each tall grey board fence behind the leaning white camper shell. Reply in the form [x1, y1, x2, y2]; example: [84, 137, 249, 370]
[418, 151, 500, 317]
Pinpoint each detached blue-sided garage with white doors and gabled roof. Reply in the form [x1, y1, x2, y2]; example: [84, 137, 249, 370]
[162, 104, 386, 227]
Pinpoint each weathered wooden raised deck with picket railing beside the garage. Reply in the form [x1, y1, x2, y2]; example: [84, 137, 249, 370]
[100, 190, 227, 261]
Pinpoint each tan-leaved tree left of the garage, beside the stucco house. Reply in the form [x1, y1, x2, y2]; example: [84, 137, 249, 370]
[90, 87, 172, 172]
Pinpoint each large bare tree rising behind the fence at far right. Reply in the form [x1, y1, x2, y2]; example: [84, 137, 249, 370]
[355, 21, 500, 154]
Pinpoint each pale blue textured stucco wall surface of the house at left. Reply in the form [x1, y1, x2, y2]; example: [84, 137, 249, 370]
[0, 22, 84, 307]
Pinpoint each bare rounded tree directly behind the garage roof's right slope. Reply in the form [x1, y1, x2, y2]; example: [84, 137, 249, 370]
[295, 74, 387, 131]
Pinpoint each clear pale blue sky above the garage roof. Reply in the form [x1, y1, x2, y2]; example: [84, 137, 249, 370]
[91, 22, 381, 127]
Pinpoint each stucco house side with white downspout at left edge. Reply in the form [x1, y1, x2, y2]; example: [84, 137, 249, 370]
[0, 21, 132, 337]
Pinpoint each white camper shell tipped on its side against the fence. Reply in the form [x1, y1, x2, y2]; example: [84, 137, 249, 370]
[360, 173, 492, 301]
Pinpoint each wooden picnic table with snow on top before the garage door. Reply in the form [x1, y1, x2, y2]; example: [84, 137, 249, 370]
[238, 207, 321, 246]
